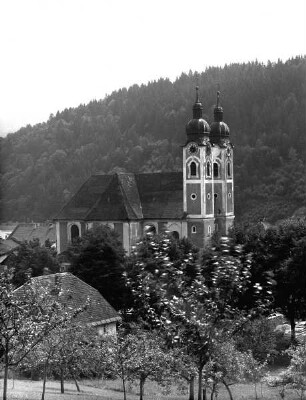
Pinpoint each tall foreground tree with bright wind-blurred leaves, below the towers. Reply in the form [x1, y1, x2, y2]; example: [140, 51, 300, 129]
[127, 236, 270, 400]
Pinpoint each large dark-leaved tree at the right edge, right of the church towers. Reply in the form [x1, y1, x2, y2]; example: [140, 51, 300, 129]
[234, 219, 306, 342]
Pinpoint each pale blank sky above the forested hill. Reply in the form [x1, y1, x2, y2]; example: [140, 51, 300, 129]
[0, 0, 306, 136]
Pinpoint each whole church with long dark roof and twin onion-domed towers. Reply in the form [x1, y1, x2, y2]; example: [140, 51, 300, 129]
[55, 87, 234, 253]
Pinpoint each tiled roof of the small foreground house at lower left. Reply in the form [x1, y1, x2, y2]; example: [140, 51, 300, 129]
[16, 272, 121, 326]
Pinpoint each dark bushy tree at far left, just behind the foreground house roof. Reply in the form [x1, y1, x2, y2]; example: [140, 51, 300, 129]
[6, 239, 59, 286]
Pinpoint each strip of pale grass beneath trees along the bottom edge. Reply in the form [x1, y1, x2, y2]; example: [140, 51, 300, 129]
[0, 379, 299, 400]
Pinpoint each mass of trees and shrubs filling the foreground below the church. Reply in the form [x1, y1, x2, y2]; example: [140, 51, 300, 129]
[0, 220, 306, 400]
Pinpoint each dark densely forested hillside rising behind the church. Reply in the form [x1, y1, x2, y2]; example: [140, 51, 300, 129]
[1, 57, 306, 222]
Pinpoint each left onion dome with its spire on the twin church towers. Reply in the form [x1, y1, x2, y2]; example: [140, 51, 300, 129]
[186, 86, 210, 144]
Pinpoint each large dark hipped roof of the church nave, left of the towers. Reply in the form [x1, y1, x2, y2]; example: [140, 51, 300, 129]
[55, 172, 183, 221]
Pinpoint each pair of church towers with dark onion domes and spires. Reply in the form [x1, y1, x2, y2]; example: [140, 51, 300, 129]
[183, 87, 234, 248]
